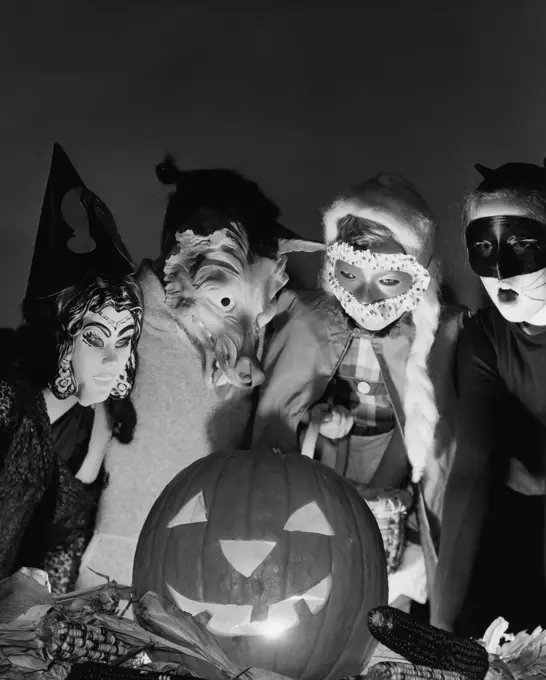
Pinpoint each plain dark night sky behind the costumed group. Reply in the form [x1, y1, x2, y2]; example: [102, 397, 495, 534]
[0, 0, 546, 325]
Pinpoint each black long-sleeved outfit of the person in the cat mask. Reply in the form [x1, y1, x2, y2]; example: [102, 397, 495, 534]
[433, 306, 546, 636]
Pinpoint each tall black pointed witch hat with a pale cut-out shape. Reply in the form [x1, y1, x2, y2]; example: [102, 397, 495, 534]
[27, 143, 135, 299]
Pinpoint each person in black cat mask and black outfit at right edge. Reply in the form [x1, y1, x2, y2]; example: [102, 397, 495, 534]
[432, 163, 546, 635]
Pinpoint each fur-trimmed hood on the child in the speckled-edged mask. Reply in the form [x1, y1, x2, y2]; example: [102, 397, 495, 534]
[323, 174, 435, 267]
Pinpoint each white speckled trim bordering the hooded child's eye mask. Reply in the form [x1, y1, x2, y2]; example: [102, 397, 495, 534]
[325, 241, 430, 331]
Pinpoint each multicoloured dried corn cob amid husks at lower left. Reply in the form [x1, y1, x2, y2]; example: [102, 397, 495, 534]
[40, 619, 131, 662]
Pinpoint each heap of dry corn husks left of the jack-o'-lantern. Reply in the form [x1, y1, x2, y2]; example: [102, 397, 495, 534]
[0, 573, 287, 680]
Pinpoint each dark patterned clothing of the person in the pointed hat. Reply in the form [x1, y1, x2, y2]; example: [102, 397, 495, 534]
[0, 330, 105, 593]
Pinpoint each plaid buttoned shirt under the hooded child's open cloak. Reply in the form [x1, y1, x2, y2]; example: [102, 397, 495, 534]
[328, 334, 394, 435]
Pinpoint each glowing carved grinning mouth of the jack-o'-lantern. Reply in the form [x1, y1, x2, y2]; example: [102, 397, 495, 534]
[167, 575, 332, 637]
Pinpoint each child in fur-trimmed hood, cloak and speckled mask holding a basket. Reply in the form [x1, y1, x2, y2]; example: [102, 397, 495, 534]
[254, 175, 461, 604]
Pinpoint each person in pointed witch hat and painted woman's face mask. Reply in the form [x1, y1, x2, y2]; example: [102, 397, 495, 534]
[0, 144, 142, 593]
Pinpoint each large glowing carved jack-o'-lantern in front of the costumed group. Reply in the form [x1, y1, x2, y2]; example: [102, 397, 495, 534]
[133, 450, 387, 680]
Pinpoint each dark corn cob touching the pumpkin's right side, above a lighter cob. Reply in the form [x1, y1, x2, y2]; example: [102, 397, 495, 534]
[368, 606, 489, 680]
